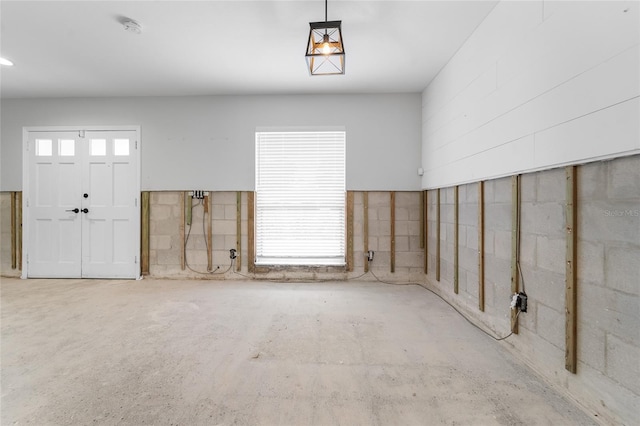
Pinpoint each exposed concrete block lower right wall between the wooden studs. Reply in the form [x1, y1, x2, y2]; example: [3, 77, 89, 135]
[426, 155, 640, 425]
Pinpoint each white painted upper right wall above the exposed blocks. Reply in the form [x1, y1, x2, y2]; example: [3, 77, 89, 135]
[422, 1, 640, 188]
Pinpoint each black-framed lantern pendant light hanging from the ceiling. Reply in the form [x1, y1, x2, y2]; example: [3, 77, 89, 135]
[305, 0, 344, 75]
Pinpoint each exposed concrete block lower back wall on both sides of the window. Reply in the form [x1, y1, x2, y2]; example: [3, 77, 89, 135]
[150, 191, 423, 282]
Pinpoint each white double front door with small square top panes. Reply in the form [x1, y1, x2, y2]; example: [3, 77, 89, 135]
[25, 130, 140, 278]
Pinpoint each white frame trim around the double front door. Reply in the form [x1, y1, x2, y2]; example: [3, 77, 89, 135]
[20, 125, 142, 280]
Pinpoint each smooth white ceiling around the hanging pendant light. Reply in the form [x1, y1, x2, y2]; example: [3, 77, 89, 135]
[0, 0, 496, 98]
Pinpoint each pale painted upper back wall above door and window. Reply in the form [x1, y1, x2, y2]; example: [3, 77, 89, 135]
[0, 94, 421, 191]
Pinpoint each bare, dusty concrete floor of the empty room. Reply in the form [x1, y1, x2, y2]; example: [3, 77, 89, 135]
[0, 279, 594, 425]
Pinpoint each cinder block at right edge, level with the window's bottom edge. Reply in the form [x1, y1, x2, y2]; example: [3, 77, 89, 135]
[605, 247, 640, 298]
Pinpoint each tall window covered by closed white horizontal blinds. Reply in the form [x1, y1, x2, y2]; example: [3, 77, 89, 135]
[256, 131, 346, 265]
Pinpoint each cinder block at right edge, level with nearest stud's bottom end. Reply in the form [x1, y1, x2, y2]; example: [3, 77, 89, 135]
[606, 329, 640, 395]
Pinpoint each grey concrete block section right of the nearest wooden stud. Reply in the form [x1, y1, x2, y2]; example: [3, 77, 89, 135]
[569, 155, 640, 424]
